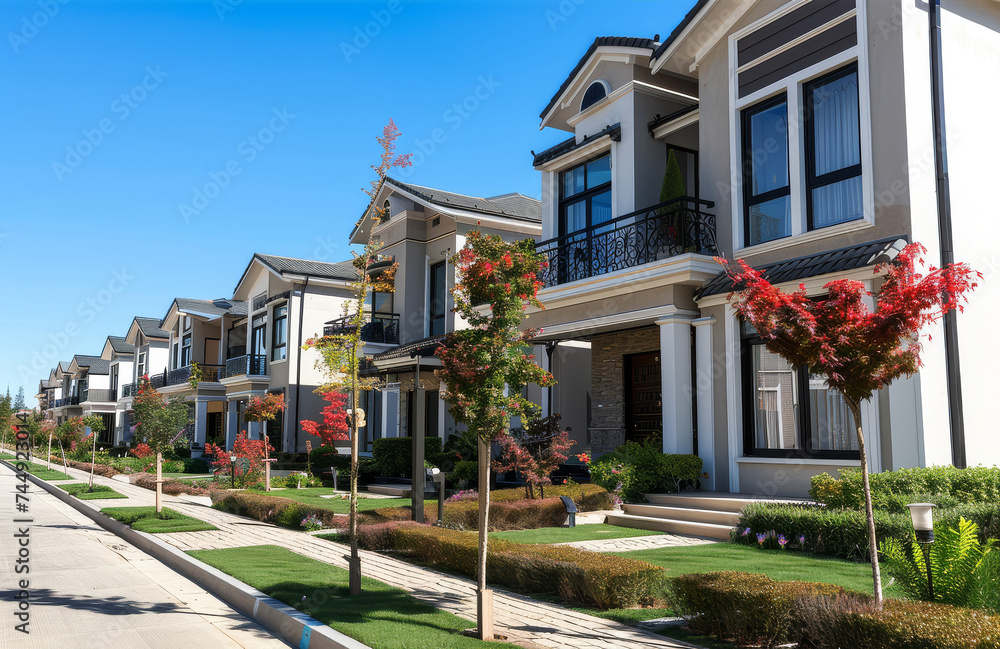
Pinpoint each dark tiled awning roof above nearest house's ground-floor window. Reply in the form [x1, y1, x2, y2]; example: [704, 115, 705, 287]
[697, 236, 906, 299]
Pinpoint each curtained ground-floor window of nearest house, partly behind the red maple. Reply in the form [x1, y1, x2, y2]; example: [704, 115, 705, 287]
[742, 323, 859, 458]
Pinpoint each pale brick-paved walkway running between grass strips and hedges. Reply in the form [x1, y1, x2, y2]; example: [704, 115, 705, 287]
[17, 458, 704, 649]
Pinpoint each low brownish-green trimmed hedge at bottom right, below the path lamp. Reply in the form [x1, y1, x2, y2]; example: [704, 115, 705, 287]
[670, 572, 1000, 649]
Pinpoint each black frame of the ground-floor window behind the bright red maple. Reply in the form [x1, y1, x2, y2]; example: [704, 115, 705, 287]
[738, 321, 861, 460]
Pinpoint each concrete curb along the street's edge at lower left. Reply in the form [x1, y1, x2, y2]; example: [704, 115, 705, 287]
[0, 460, 371, 649]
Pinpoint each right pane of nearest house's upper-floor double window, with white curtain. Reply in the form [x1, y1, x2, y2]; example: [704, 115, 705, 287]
[802, 64, 864, 230]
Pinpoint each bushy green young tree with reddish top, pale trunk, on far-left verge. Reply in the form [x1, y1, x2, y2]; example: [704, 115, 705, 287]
[132, 376, 191, 514]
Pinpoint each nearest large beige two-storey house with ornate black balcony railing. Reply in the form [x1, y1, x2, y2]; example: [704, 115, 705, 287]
[530, 0, 1000, 496]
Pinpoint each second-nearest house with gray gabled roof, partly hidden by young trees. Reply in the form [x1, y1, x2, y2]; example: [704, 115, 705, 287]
[350, 177, 542, 453]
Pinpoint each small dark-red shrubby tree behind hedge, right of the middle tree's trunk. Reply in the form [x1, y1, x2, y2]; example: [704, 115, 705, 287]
[493, 414, 576, 499]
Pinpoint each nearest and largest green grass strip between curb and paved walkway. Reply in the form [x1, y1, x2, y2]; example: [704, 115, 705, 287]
[189, 545, 511, 649]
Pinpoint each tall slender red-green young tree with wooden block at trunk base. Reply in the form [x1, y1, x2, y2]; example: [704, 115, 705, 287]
[435, 231, 554, 640]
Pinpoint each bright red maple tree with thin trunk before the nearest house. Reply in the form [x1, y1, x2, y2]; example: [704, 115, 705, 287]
[717, 243, 982, 606]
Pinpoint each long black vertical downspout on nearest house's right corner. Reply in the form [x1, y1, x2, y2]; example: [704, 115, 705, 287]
[927, 0, 966, 469]
